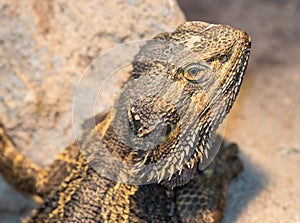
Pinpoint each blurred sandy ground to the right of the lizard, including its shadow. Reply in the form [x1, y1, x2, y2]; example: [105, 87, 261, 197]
[180, 0, 300, 223]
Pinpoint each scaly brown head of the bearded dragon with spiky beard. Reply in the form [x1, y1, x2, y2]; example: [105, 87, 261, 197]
[93, 22, 251, 187]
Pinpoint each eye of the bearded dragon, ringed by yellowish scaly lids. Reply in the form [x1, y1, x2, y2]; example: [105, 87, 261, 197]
[181, 63, 209, 83]
